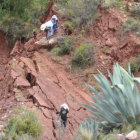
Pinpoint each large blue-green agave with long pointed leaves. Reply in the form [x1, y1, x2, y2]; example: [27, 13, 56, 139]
[85, 63, 140, 126]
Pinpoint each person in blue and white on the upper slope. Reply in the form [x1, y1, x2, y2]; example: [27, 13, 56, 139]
[40, 15, 58, 38]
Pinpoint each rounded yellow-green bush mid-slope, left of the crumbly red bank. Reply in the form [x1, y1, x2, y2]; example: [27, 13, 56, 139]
[72, 43, 95, 68]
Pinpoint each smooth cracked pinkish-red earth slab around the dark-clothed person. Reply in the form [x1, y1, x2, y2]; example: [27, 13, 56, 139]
[11, 42, 90, 140]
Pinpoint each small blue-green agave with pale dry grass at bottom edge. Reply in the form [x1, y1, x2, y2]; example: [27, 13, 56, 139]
[75, 119, 98, 140]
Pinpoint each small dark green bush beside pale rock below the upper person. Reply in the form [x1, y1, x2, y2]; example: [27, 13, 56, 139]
[52, 36, 73, 55]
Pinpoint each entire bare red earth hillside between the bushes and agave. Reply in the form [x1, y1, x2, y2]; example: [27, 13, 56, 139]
[0, 1, 140, 140]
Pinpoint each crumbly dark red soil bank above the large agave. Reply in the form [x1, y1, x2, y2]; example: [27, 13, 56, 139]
[90, 8, 140, 70]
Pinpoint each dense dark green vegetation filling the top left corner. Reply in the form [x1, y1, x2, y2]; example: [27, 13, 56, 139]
[0, 0, 49, 47]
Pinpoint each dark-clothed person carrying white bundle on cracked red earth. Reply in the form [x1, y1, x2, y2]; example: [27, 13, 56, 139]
[56, 103, 69, 128]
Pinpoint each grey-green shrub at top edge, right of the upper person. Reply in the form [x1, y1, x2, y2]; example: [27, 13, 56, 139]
[57, 0, 101, 28]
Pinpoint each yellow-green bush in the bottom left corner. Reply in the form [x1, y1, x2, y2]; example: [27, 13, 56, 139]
[5, 110, 42, 140]
